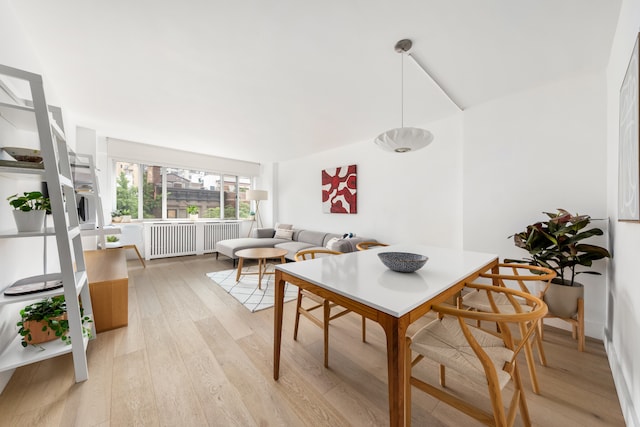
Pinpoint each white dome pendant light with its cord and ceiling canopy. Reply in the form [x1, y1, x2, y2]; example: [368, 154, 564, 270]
[374, 39, 433, 153]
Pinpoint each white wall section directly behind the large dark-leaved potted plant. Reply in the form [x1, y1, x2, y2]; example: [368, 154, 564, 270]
[463, 75, 607, 339]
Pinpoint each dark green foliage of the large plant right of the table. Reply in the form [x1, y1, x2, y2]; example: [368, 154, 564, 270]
[507, 209, 611, 286]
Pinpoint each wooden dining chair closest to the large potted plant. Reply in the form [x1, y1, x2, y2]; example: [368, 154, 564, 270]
[458, 263, 556, 394]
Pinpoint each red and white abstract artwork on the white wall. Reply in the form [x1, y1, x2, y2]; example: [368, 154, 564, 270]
[322, 165, 358, 213]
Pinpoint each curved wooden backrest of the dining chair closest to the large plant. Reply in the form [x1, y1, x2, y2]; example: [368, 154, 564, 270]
[480, 262, 556, 298]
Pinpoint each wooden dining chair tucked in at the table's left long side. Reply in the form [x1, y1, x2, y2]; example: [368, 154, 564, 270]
[293, 249, 366, 368]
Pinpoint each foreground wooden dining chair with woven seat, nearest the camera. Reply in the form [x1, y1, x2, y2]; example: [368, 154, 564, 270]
[405, 283, 548, 426]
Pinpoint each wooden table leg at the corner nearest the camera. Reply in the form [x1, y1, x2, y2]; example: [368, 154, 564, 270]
[379, 314, 409, 427]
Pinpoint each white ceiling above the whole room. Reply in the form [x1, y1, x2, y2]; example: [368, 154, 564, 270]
[10, 0, 620, 162]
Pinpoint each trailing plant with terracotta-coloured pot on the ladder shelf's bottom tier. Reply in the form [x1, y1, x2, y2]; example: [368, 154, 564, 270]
[16, 295, 92, 347]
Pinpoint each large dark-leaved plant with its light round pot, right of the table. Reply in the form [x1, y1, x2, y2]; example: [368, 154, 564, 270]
[507, 209, 611, 318]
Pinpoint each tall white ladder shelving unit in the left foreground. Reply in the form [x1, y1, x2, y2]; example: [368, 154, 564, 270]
[0, 65, 95, 382]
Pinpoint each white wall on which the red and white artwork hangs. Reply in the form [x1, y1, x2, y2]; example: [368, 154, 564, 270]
[274, 112, 462, 247]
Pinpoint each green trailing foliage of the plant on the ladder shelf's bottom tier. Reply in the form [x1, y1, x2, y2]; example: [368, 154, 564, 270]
[16, 295, 92, 347]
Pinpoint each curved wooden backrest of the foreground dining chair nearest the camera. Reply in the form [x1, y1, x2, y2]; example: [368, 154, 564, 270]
[431, 283, 548, 364]
